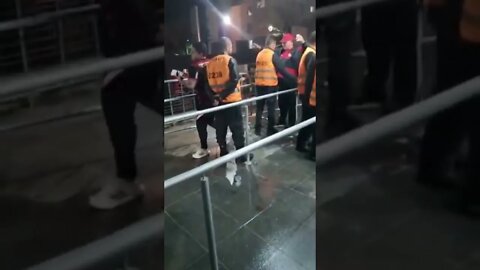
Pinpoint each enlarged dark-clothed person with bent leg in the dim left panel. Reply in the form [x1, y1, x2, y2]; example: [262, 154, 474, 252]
[89, 0, 163, 209]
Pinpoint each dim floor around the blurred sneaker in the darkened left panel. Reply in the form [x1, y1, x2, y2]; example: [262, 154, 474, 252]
[0, 89, 163, 270]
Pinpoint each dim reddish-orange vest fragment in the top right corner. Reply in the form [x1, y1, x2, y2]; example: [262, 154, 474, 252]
[460, 0, 480, 43]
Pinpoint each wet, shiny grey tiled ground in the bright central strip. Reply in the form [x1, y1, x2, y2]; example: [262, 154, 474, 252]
[165, 125, 315, 270]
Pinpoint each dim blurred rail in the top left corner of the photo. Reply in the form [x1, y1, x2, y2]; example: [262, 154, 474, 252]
[0, 5, 100, 32]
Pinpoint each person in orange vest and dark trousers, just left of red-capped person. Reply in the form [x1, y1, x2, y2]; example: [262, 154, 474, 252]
[255, 36, 295, 136]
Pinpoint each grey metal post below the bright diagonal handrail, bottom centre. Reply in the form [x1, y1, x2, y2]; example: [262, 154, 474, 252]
[200, 176, 218, 270]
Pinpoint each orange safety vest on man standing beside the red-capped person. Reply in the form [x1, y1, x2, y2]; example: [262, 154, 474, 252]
[255, 48, 278, 86]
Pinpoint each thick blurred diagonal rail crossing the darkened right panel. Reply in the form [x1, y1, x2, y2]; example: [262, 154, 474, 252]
[316, 77, 480, 166]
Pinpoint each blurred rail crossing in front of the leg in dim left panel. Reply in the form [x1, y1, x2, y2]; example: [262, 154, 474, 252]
[0, 47, 164, 96]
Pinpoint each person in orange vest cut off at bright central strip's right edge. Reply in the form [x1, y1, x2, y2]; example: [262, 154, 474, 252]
[296, 31, 317, 160]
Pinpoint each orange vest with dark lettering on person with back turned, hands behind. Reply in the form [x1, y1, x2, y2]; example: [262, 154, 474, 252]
[207, 54, 242, 103]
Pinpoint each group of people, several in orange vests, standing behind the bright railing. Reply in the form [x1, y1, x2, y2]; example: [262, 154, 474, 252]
[179, 32, 316, 162]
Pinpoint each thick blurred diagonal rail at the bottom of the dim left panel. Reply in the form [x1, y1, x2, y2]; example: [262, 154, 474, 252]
[28, 214, 164, 270]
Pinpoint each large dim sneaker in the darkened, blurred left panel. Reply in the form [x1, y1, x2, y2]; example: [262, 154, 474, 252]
[89, 178, 141, 210]
